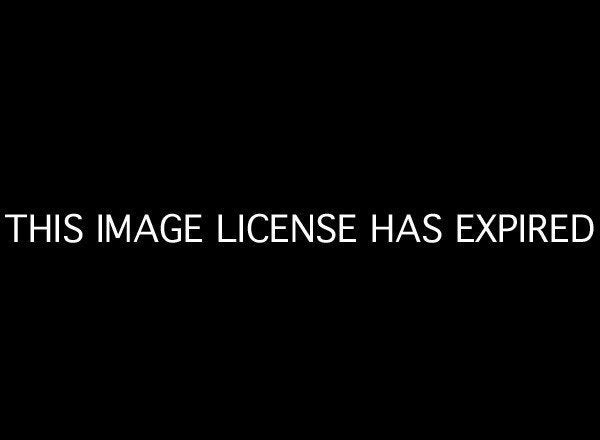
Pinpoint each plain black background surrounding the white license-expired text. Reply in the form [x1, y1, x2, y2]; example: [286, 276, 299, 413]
[1, 5, 598, 433]
